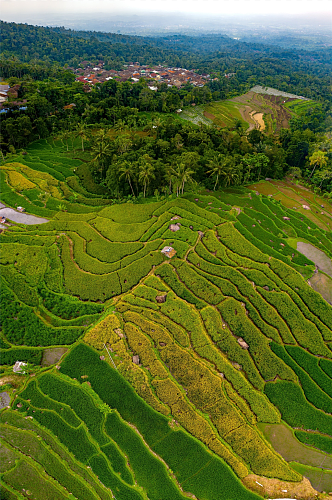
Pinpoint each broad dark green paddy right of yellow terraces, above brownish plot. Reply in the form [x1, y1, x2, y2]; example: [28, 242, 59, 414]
[264, 380, 332, 435]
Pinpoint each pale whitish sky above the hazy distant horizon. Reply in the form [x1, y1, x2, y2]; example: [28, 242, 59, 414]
[0, 0, 332, 22]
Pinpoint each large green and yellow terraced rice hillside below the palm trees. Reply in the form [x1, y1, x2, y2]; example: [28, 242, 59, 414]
[0, 139, 332, 500]
